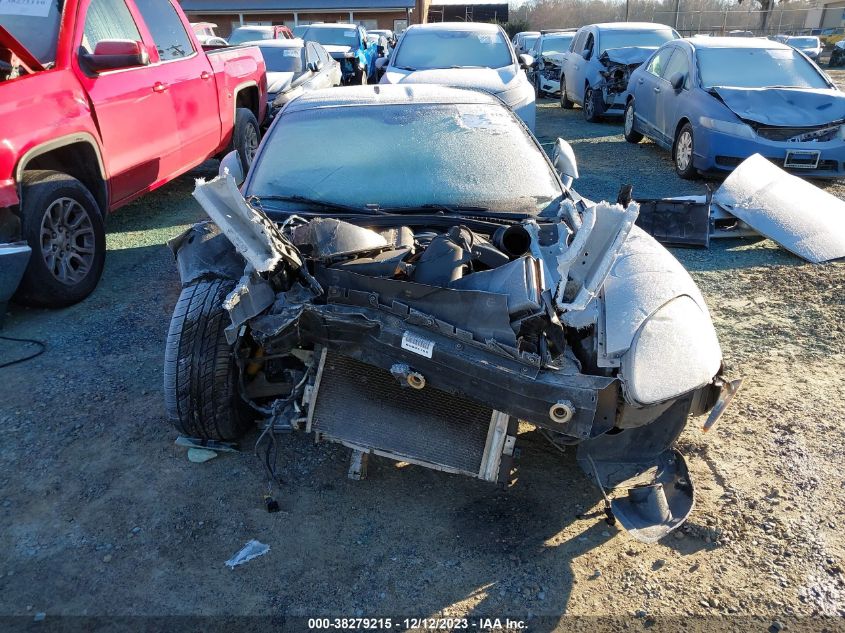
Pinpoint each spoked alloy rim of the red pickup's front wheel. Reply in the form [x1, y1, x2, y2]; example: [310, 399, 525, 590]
[41, 198, 96, 286]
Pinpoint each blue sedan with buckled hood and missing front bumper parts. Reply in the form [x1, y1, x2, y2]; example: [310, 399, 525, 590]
[624, 37, 845, 178]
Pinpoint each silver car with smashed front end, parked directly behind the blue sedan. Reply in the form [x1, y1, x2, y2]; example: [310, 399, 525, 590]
[560, 22, 680, 121]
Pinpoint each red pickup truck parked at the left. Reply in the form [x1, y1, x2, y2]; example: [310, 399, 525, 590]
[0, 0, 267, 307]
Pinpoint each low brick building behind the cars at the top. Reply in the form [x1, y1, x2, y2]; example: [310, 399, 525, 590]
[179, 0, 430, 37]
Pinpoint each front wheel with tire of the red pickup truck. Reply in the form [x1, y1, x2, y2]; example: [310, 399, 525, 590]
[15, 170, 106, 308]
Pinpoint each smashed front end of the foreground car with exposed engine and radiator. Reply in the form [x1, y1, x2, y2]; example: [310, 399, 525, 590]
[166, 169, 737, 541]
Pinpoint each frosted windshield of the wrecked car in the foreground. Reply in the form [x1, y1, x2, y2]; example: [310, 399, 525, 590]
[247, 104, 562, 215]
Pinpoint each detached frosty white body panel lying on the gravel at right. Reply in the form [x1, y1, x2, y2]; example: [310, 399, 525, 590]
[713, 154, 845, 264]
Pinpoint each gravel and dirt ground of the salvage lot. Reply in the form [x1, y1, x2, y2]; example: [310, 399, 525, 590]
[0, 82, 845, 631]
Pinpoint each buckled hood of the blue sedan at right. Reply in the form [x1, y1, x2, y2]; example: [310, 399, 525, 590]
[712, 88, 845, 127]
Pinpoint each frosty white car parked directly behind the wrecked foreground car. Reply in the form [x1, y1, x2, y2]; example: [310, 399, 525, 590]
[381, 22, 536, 132]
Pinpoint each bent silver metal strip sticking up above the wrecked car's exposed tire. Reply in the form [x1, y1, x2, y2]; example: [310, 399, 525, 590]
[194, 174, 302, 273]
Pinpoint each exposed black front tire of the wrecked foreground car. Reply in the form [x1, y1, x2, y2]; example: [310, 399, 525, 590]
[164, 279, 251, 441]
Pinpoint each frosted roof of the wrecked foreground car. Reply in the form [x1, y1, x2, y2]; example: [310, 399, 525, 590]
[285, 84, 506, 112]
